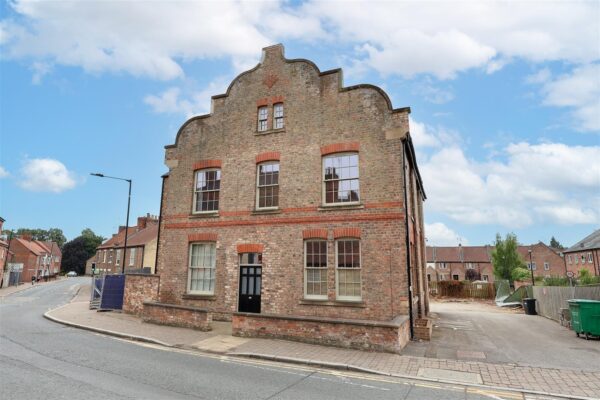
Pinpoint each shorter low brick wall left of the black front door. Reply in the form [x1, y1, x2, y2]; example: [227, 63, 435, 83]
[142, 301, 212, 331]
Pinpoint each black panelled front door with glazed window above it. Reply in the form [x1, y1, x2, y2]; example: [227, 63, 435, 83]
[238, 253, 262, 313]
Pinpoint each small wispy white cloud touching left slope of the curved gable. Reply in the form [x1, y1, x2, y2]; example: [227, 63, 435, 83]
[144, 77, 229, 118]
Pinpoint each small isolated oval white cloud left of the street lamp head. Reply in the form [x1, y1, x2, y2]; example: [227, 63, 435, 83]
[19, 158, 76, 193]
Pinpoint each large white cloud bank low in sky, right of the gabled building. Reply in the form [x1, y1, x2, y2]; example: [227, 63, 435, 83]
[421, 142, 600, 228]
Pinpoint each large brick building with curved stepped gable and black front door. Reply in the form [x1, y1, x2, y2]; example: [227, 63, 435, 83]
[152, 45, 428, 351]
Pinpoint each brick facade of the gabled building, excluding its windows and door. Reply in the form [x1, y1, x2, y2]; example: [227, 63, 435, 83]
[157, 46, 426, 340]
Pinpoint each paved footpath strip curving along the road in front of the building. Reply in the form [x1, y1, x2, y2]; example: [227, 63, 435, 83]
[47, 289, 600, 399]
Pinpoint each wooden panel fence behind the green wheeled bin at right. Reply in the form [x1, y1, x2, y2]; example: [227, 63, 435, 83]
[533, 285, 600, 321]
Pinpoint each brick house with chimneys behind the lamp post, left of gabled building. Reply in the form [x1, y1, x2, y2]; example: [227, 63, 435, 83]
[85, 214, 158, 275]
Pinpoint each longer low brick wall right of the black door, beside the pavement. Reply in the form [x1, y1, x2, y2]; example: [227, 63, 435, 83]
[232, 313, 410, 353]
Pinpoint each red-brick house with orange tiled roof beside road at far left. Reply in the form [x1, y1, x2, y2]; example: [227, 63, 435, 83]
[10, 235, 62, 283]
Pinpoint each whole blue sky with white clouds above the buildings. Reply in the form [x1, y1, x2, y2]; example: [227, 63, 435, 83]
[0, 0, 600, 246]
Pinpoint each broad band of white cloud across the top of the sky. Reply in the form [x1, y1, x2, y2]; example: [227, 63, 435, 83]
[0, 0, 600, 79]
